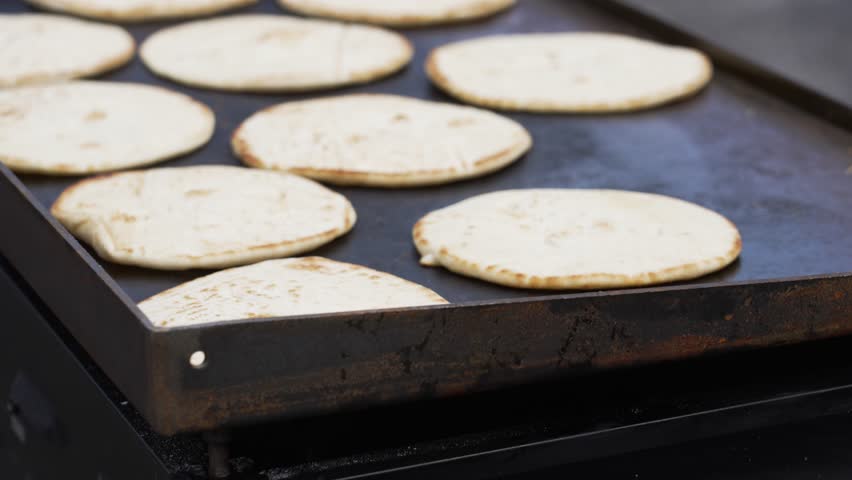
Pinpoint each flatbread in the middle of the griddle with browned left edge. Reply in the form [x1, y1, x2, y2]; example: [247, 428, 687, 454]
[232, 95, 532, 187]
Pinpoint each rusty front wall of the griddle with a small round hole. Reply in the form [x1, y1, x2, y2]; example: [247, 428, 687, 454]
[152, 275, 852, 431]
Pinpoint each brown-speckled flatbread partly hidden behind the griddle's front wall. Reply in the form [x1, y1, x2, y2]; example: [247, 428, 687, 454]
[139, 257, 447, 327]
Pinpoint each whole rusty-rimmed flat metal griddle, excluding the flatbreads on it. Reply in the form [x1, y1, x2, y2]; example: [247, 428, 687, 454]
[0, 0, 852, 434]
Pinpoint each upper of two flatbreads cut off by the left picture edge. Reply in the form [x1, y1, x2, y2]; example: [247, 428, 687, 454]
[0, 13, 136, 88]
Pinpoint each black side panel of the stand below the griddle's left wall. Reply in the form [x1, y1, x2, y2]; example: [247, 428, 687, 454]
[0, 257, 173, 480]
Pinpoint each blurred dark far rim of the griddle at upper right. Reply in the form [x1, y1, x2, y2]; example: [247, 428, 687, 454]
[585, 0, 852, 130]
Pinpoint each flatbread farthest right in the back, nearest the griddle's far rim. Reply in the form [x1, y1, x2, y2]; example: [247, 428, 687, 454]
[426, 33, 713, 112]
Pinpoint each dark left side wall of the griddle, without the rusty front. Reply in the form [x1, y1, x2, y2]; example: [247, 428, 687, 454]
[0, 167, 161, 430]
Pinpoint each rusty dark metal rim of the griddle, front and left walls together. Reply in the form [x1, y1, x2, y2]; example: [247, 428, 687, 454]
[0, 0, 852, 434]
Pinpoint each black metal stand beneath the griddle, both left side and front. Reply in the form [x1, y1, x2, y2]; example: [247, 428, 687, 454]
[5, 248, 852, 479]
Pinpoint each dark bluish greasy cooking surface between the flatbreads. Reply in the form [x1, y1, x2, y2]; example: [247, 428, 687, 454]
[6, 0, 852, 302]
